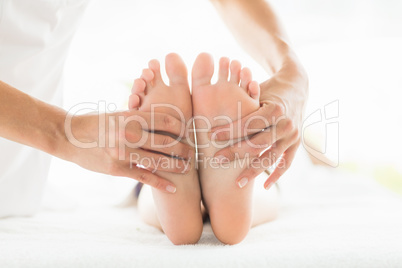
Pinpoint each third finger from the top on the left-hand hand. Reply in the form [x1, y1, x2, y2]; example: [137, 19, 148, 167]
[129, 149, 191, 174]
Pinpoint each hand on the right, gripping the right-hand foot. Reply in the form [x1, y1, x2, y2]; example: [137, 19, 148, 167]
[210, 66, 308, 190]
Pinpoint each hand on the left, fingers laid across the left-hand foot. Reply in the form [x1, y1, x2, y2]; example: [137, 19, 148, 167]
[59, 110, 194, 193]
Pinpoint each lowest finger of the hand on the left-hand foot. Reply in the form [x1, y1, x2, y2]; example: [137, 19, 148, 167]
[120, 166, 176, 194]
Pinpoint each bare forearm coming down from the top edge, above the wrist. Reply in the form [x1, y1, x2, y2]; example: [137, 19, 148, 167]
[211, 0, 307, 79]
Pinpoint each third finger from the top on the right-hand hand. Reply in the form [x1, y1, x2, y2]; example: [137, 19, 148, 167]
[236, 140, 287, 188]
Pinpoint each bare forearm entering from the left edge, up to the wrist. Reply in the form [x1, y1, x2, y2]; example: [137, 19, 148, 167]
[0, 81, 66, 156]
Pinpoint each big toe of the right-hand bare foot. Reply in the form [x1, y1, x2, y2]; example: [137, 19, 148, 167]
[191, 53, 214, 87]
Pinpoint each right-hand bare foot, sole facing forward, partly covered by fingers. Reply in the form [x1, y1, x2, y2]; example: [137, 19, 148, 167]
[192, 53, 260, 244]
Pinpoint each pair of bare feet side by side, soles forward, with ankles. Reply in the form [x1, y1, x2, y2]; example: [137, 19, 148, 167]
[129, 53, 277, 245]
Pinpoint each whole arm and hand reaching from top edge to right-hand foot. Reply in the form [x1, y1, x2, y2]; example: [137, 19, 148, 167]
[211, 0, 308, 190]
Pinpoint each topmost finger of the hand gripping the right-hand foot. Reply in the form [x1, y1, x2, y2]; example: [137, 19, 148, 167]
[209, 102, 285, 141]
